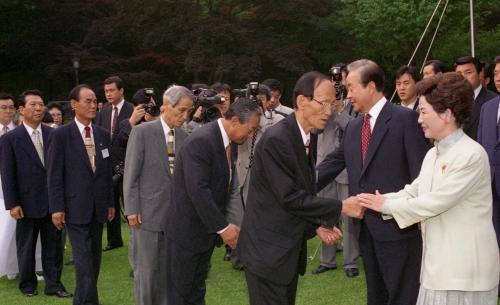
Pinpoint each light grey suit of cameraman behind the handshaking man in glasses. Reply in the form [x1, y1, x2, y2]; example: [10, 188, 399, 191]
[317, 102, 359, 269]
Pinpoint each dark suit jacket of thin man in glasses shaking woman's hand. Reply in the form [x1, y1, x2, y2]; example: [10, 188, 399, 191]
[238, 114, 342, 285]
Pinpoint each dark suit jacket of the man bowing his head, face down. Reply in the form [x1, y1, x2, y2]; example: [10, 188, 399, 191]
[167, 121, 230, 253]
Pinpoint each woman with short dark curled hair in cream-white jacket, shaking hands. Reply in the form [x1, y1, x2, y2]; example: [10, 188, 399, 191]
[358, 72, 500, 305]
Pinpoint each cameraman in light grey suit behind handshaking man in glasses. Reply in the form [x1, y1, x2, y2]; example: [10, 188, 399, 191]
[312, 63, 359, 278]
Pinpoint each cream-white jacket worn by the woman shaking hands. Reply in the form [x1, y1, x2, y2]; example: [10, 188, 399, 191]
[384, 129, 499, 291]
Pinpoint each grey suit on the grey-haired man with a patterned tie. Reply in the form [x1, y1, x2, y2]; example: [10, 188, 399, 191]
[123, 119, 187, 305]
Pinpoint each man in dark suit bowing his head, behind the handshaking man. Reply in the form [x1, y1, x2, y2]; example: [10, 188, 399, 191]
[167, 98, 261, 305]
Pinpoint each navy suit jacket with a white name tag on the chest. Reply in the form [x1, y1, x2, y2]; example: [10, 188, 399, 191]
[46, 121, 114, 224]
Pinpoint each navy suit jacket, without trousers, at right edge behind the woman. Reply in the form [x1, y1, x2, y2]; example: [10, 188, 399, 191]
[477, 96, 500, 194]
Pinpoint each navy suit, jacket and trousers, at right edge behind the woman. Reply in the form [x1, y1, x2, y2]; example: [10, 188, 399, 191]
[477, 96, 500, 246]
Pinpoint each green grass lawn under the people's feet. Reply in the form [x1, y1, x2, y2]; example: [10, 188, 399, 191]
[0, 221, 366, 305]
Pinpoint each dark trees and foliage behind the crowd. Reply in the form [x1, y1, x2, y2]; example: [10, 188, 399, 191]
[0, 0, 500, 104]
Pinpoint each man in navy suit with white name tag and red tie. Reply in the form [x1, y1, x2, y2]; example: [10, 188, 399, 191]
[47, 85, 115, 305]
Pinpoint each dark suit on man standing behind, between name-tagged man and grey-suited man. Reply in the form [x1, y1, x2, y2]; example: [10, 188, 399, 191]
[95, 101, 134, 247]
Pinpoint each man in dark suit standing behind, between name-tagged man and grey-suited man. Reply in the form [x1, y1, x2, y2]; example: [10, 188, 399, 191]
[94, 76, 134, 251]
